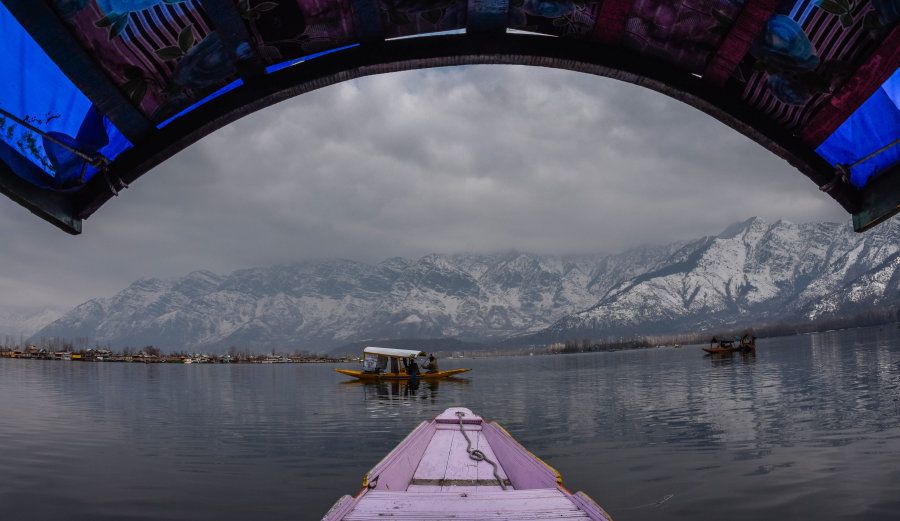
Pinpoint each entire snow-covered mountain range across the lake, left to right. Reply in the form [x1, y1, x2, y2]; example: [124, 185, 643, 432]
[29, 218, 900, 351]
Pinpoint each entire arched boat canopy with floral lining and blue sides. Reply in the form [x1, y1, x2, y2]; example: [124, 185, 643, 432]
[0, 0, 900, 233]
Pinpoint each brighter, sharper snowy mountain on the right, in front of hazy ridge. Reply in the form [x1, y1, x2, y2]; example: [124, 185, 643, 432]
[546, 214, 900, 337]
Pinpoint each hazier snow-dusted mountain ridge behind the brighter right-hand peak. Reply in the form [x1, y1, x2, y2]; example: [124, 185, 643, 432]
[36, 244, 680, 350]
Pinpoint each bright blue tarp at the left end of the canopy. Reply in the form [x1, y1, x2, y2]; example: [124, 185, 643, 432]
[0, 3, 131, 188]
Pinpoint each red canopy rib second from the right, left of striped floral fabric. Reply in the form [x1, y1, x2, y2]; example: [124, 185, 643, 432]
[703, 0, 779, 86]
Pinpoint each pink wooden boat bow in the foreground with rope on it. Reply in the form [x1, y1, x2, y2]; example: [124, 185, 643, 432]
[323, 407, 612, 521]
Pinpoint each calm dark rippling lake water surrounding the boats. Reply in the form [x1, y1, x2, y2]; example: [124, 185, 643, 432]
[0, 324, 900, 521]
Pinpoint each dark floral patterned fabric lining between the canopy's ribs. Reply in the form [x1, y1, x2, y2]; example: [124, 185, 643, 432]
[48, 0, 900, 133]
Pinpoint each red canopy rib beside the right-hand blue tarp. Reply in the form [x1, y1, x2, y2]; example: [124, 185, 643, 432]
[800, 26, 900, 148]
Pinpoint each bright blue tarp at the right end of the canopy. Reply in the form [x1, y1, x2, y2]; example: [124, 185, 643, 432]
[816, 69, 900, 188]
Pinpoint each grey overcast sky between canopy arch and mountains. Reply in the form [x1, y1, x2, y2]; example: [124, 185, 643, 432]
[0, 66, 848, 307]
